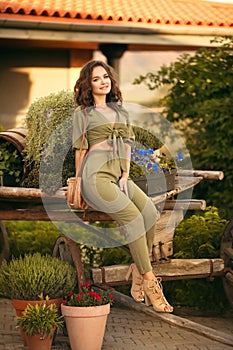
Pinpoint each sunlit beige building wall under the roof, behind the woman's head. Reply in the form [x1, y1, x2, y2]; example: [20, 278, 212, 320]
[0, 45, 191, 130]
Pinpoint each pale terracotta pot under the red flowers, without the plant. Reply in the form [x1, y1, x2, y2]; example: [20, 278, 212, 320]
[61, 304, 110, 350]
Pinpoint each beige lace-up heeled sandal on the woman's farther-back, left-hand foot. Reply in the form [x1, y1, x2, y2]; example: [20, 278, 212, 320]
[125, 264, 144, 302]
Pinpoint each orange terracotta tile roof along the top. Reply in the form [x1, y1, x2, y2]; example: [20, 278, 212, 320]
[0, 0, 233, 27]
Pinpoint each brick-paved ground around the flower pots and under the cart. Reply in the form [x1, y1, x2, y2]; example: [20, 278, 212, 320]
[0, 299, 233, 350]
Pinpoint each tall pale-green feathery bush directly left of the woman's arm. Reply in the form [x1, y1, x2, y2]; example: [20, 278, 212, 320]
[22, 91, 75, 192]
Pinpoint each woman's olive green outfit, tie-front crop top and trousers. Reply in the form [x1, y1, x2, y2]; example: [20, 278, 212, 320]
[73, 107, 157, 274]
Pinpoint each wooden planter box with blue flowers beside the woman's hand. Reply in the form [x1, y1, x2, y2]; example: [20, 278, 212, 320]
[130, 148, 183, 195]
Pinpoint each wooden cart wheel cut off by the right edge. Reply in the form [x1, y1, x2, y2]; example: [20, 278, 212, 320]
[220, 220, 233, 306]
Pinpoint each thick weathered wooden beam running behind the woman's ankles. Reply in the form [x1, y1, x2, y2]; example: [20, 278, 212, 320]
[92, 259, 224, 285]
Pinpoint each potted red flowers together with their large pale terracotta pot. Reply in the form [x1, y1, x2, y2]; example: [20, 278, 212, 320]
[61, 283, 113, 350]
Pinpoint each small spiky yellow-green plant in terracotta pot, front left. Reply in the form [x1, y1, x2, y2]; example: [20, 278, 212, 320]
[17, 297, 64, 350]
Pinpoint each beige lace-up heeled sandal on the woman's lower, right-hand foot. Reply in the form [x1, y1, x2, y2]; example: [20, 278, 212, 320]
[143, 277, 173, 312]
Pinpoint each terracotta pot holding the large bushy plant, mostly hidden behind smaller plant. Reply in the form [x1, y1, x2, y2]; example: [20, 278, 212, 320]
[12, 298, 62, 345]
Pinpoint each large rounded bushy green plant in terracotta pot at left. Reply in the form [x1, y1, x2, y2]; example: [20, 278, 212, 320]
[0, 253, 77, 344]
